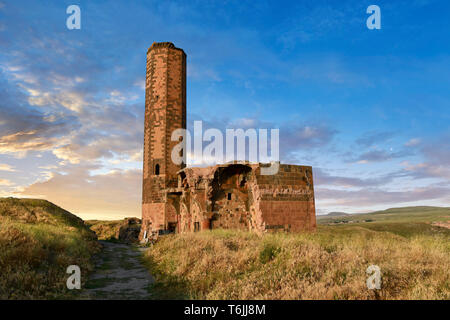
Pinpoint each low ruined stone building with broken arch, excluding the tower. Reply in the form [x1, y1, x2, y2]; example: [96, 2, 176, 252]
[175, 164, 316, 232]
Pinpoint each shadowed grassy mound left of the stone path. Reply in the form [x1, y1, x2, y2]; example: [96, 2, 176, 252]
[0, 198, 98, 299]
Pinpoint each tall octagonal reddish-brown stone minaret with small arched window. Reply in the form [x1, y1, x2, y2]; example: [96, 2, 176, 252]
[141, 42, 186, 236]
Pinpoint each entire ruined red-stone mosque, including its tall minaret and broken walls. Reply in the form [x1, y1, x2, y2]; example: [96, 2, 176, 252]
[141, 42, 316, 238]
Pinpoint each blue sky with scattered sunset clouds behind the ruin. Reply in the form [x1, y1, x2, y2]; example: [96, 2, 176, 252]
[0, 0, 450, 218]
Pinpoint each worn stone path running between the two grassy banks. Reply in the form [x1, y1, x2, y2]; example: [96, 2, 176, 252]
[83, 241, 154, 300]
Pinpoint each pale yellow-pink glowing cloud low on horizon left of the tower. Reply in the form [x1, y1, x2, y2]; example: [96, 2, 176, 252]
[16, 165, 142, 219]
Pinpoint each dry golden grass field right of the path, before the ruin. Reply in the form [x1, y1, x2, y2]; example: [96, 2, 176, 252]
[146, 207, 450, 300]
